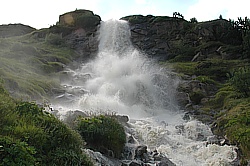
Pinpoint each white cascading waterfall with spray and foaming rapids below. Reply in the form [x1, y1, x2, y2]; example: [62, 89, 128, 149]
[54, 20, 237, 166]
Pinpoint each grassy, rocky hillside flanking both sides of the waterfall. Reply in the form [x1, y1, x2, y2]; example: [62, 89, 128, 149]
[0, 10, 250, 165]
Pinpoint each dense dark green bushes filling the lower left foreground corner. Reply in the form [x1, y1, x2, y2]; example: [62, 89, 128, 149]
[0, 83, 92, 166]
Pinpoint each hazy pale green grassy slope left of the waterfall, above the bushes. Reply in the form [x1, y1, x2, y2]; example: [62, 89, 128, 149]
[0, 33, 75, 100]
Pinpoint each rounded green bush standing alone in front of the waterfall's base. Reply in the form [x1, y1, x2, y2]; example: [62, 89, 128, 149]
[77, 115, 126, 158]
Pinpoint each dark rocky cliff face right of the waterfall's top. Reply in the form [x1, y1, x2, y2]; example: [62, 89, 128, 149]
[121, 15, 242, 61]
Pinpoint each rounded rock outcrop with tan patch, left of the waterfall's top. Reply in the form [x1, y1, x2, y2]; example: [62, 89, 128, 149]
[57, 10, 101, 60]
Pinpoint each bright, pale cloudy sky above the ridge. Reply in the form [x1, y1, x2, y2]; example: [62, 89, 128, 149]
[0, 0, 250, 29]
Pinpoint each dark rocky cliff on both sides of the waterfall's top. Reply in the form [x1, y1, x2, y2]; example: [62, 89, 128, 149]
[20, 10, 243, 61]
